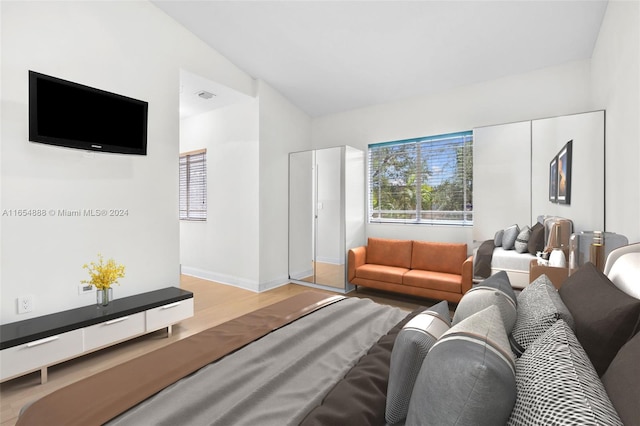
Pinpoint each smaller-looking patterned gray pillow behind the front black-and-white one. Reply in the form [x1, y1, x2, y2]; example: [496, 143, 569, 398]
[511, 275, 574, 355]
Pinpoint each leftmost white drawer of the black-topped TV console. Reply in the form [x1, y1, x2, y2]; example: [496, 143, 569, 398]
[0, 330, 82, 380]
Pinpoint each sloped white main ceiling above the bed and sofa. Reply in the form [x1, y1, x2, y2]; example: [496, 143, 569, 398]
[152, 0, 606, 116]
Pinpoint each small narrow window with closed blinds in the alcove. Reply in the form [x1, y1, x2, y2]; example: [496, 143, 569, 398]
[180, 149, 207, 221]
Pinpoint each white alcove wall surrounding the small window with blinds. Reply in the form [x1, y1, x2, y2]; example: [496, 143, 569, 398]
[180, 97, 259, 290]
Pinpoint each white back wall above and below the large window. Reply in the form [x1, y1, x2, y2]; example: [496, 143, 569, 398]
[312, 61, 589, 245]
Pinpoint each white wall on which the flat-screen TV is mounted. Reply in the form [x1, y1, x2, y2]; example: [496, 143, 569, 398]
[0, 1, 253, 323]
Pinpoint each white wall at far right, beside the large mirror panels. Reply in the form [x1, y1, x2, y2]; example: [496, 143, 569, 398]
[591, 0, 640, 242]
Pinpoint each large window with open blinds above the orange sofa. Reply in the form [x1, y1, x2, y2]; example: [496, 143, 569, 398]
[369, 131, 473, 226]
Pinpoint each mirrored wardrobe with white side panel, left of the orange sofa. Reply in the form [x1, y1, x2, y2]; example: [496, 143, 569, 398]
[289, 146, 365, 292]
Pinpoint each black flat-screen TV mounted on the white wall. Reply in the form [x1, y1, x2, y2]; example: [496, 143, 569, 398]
[29, 71, 149, 155]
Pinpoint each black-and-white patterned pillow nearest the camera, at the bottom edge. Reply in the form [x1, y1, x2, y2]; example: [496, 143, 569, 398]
[507, 320, 622, 426]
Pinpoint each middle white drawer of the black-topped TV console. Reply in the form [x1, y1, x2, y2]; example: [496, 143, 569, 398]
[84, 312, 144, 351]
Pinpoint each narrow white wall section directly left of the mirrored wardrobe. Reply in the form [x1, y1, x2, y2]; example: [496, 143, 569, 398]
[258, 81, 311, 290]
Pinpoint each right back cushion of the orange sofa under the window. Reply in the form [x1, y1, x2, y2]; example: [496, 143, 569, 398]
[411, 241, 467, 275]
